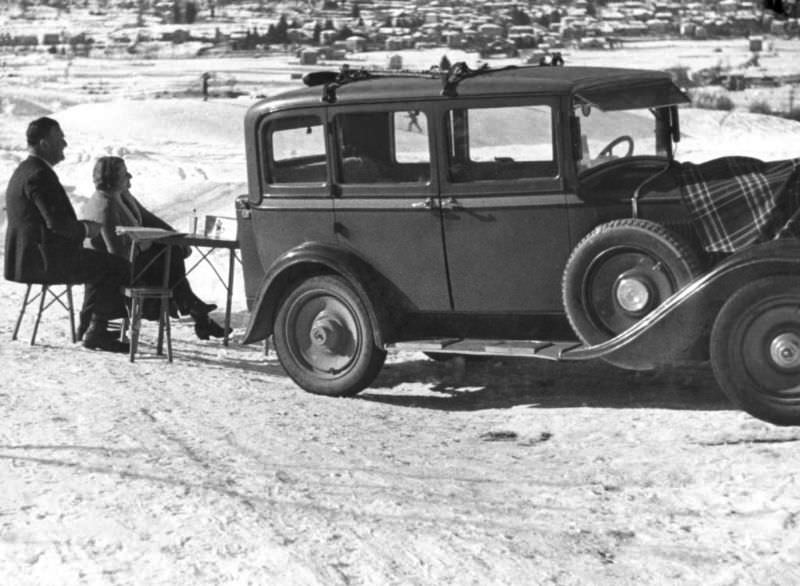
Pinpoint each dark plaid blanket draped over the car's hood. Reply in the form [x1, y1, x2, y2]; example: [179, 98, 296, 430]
[678, 157, 800, 252]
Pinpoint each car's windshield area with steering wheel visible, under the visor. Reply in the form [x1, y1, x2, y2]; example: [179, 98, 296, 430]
[575, 106, 669, 171]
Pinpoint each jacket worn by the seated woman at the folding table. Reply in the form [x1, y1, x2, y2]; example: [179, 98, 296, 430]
[81, 190, 174, 258]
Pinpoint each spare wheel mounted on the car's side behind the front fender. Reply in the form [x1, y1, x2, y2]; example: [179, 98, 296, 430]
[561, 218, 702, 344]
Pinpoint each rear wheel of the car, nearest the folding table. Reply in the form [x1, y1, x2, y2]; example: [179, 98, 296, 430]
[274, 275, 386, 397]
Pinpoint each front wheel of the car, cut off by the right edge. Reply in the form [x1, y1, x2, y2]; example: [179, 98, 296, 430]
[710, 276, 800, 425]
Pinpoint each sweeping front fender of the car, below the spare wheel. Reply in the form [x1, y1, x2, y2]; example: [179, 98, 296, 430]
[561, 240, 800, 370]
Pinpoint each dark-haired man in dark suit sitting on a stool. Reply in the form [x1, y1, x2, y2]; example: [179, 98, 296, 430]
[4, 117, 130, 352]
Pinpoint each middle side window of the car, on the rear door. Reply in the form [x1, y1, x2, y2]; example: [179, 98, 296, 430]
[334, 110, 430, 184]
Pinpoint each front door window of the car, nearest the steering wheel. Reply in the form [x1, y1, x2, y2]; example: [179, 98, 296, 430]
[447, 105, 558, 183]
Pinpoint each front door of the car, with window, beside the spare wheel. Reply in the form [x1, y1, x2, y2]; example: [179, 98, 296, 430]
[437, 98, 570, 313]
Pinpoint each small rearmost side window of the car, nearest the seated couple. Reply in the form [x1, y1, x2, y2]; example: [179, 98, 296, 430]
[264, 115, 328, 184]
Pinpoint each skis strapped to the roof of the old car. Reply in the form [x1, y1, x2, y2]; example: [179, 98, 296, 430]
[303, 61, 517, 104]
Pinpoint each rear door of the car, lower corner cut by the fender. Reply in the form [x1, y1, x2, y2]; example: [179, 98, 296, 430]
[329, 105, 450, 311]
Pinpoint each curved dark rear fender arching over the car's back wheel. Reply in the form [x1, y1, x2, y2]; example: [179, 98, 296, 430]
[242, 242, 406, 346]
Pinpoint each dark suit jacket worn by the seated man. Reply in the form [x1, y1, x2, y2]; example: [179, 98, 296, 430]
[4, 156, 86, 283]
